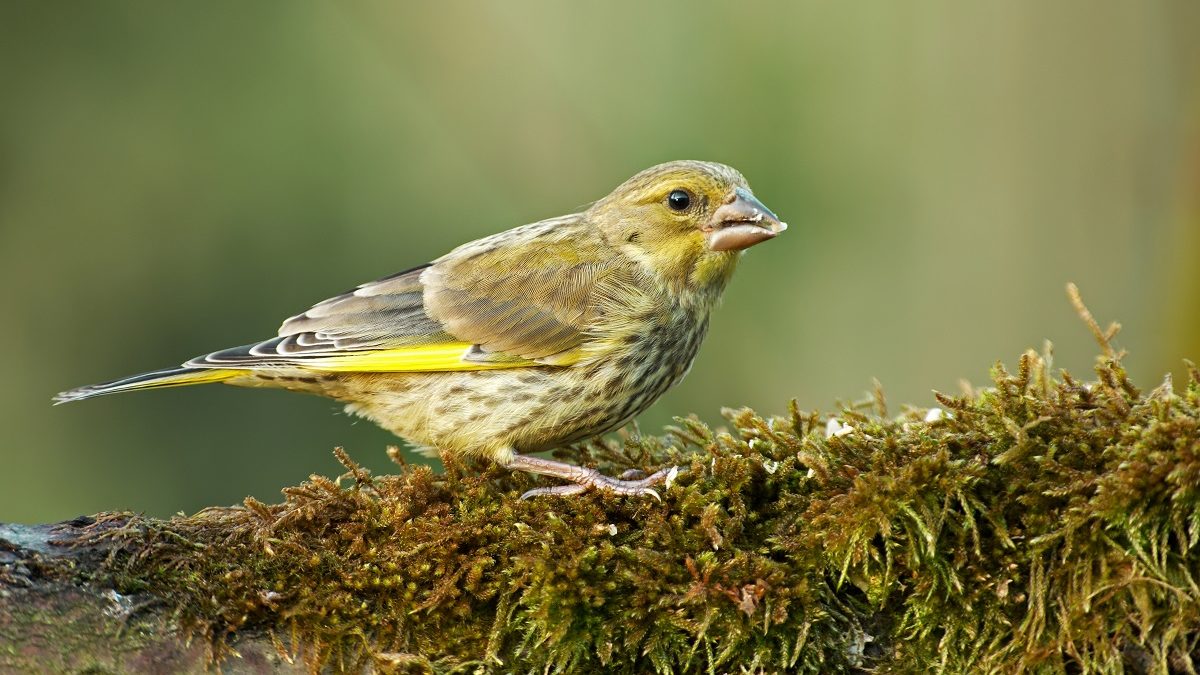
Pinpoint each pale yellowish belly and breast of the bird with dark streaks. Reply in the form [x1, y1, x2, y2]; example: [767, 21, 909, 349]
[336, 313, 708, 459]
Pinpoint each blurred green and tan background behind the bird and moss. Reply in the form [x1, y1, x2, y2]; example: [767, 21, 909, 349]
[0, 0, 1200, 521]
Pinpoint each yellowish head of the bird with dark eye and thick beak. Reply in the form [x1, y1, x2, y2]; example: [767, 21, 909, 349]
[587, 161, 787, 287]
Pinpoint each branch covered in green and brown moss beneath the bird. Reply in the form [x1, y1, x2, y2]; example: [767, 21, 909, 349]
[0, 291, 1200, 673]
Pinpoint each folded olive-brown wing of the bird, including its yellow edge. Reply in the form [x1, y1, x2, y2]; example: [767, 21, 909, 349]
[187, 216, 604, 372]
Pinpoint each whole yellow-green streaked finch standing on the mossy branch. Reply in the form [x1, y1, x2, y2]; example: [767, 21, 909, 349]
[54, 160, 787, 498]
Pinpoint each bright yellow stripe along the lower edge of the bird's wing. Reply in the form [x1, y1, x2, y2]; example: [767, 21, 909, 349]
[296, 342, 542, 372]
